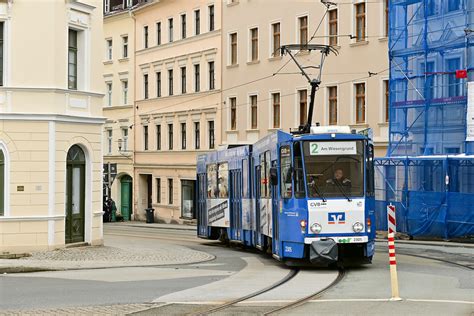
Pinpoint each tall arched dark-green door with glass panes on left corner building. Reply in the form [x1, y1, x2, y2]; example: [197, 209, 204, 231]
[66, 145, 86, 243]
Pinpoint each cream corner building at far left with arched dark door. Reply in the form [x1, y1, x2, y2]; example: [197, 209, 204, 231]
[0, 0, 104, 252]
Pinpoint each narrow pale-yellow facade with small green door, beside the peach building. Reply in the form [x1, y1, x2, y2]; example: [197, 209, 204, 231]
[102, 0, 136, 220]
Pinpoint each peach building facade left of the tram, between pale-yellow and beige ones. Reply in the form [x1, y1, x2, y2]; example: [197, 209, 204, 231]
[133, 0, 221, 223]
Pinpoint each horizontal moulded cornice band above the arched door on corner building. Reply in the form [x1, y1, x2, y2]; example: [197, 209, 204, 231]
[0, 113, 106, 124]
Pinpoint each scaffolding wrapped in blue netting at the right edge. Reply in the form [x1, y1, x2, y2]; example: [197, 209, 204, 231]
[376, 0, 474, 239]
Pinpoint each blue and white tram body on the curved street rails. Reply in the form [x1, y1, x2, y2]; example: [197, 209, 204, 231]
[197, 126, 375, 265]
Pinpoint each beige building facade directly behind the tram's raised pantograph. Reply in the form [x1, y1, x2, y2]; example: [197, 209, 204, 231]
[222, 0, 388, 156]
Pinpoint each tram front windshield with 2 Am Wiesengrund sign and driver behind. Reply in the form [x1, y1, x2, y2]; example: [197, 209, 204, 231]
[303, 140, 364, 199]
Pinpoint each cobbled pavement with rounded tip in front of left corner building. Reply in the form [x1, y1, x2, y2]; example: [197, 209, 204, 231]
[0, 237, 215, 273]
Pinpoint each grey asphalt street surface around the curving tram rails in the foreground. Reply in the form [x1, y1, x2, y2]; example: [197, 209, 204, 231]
[0, 224, 474, 315]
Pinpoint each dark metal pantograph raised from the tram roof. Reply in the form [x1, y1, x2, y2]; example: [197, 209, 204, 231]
[280, 44, 338, 134]
